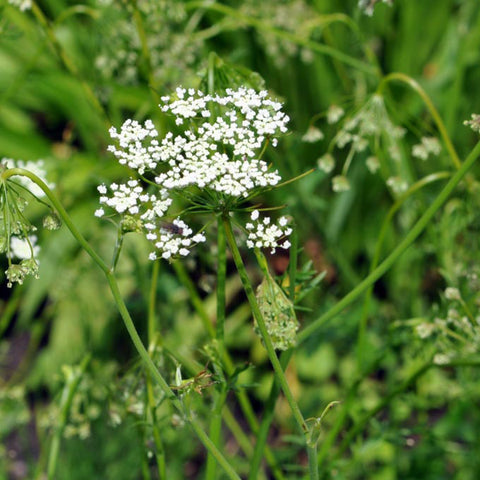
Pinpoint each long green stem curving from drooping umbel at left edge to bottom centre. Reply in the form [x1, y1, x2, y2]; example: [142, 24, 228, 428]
[0, 168, 240, 480]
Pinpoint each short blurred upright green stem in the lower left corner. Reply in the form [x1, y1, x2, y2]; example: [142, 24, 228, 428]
[47, 354, 91, 480]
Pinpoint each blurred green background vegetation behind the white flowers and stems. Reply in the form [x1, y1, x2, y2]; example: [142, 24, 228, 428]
[0, 0, 480, 480]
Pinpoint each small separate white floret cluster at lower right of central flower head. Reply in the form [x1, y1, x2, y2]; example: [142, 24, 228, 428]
[245, 210, 292, 254]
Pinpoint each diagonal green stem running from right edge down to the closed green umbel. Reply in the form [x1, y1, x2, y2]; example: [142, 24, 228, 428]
[298, 142, 480, 343]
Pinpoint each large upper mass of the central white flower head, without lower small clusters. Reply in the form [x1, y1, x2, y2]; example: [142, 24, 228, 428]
[109, 88, 289, 197]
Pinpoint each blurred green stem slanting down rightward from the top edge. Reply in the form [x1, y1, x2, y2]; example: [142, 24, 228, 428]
[185, 0, 379, 76]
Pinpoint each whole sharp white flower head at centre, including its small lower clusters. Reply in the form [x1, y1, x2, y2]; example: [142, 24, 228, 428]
[99, 87, 291, 259]
